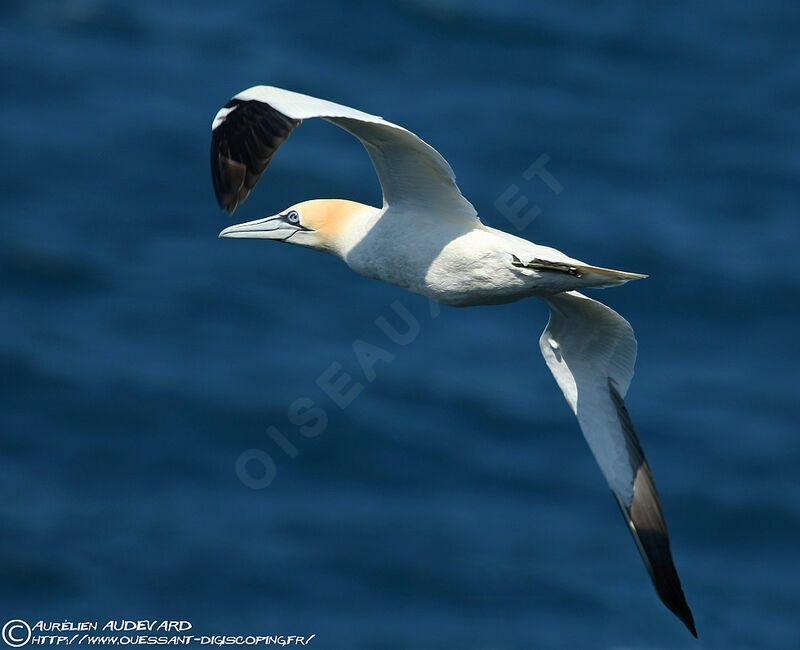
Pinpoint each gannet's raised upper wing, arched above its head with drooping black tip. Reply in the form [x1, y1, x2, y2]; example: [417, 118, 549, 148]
[211, 86, 477, 221]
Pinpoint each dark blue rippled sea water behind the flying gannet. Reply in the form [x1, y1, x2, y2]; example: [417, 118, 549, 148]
[0, 0, 800, 650]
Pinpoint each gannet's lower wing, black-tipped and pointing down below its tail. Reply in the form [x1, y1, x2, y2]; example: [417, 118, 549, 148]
[539, 291, 697, 636]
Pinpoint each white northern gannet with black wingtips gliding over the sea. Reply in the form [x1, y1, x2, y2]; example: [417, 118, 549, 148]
[211, 86, 697, 637]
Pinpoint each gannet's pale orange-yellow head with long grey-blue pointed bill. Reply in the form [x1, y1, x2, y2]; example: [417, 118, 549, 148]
[219, 199, 376, 254]
